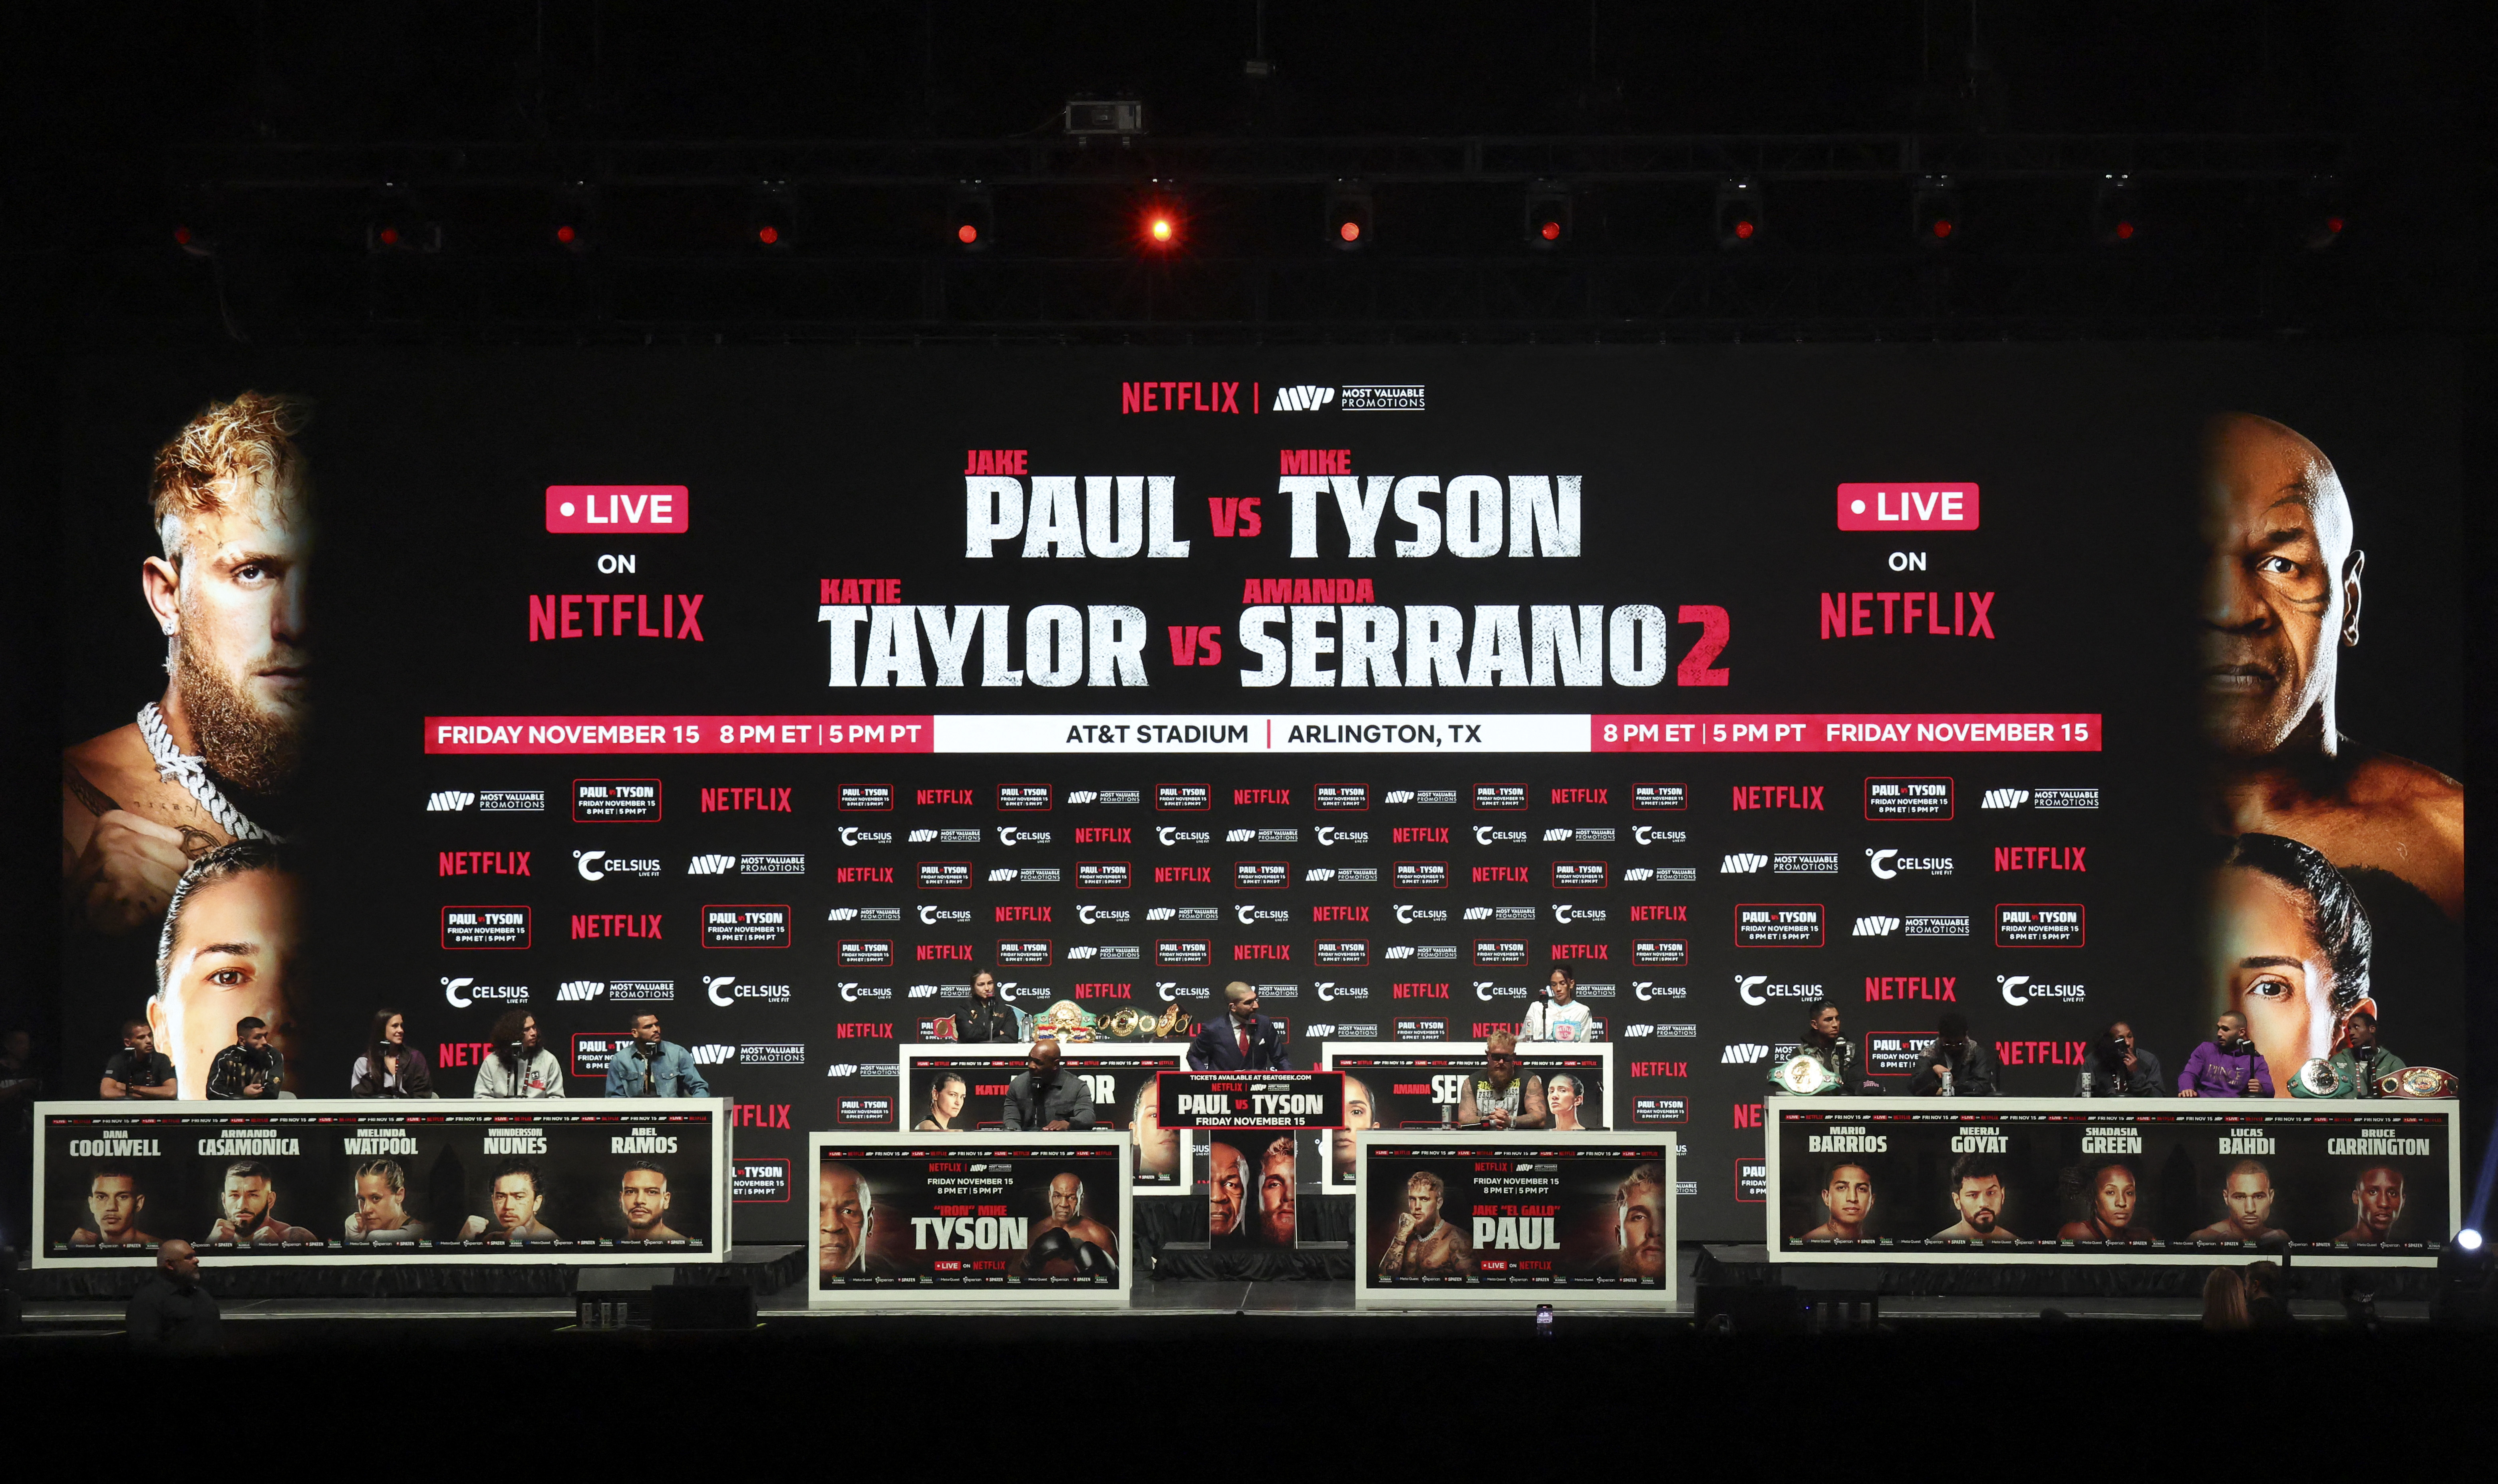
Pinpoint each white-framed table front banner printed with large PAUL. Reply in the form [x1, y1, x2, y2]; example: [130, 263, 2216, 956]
[1354, 1129, 1676, 1309]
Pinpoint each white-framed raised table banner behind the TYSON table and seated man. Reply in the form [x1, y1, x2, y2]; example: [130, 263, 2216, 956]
[897, 1042, 1186, 1197]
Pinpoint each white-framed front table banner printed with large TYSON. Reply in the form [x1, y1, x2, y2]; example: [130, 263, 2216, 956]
[809, 1132, 1129, 1307]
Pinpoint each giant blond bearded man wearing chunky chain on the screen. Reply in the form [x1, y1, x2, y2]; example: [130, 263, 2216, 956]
[60, 392, 312, 937]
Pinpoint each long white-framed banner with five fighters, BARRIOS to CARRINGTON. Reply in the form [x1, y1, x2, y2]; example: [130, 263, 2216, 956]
[1769, 1097, 2463, 1267]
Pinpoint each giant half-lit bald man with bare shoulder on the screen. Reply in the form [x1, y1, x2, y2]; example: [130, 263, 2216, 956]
[2201, 412, 2463, 922]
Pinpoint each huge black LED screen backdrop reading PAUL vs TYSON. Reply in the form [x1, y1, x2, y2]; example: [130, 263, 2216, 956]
[60, 345, 2463, 1242]
